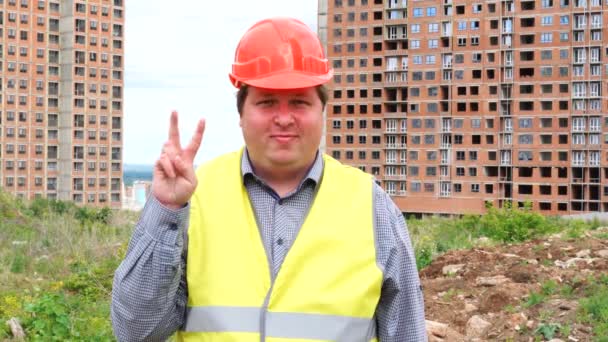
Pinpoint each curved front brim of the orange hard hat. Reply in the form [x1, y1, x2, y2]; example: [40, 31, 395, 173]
[229, 69, 333, 89]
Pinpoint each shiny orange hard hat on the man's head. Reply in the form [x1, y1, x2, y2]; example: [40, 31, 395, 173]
[229, 18, 333, 89]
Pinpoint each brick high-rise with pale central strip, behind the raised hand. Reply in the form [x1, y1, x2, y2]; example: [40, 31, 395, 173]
[0, 0, 125, 207]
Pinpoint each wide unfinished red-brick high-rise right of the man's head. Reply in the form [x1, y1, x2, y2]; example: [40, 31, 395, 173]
[318, 0, 608, 215]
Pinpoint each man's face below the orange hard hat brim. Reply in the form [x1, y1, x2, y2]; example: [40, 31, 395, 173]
[240, 87, 323, 172]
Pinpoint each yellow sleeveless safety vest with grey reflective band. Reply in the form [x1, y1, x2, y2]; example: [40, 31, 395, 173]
[178, 150, 382, 342]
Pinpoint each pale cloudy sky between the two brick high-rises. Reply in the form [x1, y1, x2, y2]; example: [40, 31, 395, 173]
[123, 0, 318, 165]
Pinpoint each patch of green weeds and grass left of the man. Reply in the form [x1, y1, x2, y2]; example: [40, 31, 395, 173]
[0, 191, 136, 341]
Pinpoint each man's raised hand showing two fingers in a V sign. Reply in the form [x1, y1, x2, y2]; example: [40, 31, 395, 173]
[152, 111, 205, 209]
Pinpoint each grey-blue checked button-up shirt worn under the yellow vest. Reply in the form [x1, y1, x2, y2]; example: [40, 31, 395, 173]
[111, 153, 427, 342]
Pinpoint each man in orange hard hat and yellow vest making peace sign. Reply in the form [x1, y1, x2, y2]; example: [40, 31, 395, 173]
[112, 18, 426, 342]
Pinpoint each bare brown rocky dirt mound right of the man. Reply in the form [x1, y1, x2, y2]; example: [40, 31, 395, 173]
[420, 228, 608, 342]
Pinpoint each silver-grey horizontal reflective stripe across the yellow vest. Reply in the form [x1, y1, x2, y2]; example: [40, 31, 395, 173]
[184, 306, 376, 342]
